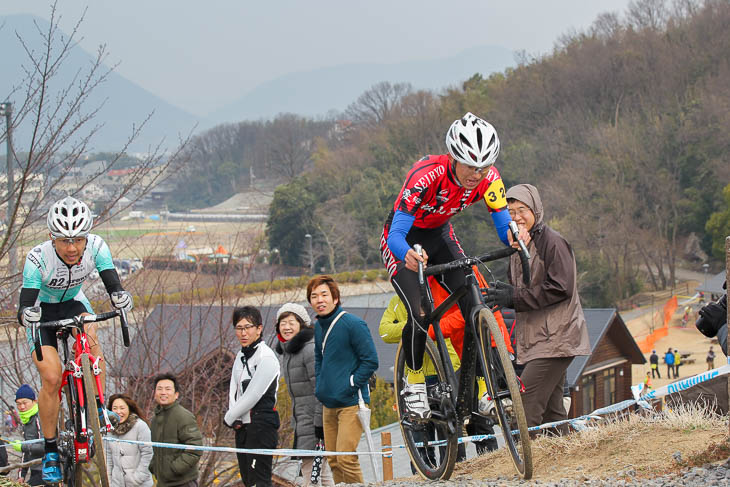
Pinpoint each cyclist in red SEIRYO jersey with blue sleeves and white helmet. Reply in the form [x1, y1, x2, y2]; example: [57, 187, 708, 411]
[380, 113, 530, 419]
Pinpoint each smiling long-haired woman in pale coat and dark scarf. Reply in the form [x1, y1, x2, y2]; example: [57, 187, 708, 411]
[105, 394, 153, 487]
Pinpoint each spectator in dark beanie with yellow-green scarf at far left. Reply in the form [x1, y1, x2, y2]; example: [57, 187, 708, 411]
[12, 384, 46, 485]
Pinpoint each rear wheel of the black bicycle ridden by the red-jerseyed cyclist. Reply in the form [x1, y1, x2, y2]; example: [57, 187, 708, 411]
[395, 338, 461, 480]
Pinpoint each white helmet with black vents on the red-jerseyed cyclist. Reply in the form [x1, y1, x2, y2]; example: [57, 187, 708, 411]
[446, 112, 499, 169]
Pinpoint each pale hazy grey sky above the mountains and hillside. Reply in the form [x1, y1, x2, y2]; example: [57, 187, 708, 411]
[0, 0, 629, 115]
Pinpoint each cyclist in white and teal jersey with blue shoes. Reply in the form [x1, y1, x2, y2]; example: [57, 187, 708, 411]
[18, 196, 133, 483]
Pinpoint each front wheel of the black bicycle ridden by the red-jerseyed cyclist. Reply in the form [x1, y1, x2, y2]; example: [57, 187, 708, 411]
[479, 307, 532, 480]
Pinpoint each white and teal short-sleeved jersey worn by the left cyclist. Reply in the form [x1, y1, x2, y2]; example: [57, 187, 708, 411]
[23, 234, 114, 311]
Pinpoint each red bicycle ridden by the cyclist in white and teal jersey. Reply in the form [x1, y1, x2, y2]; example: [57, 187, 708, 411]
[32, 310, 129, 487]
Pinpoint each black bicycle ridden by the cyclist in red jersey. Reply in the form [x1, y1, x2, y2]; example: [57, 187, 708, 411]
[395, 235, 532, 480]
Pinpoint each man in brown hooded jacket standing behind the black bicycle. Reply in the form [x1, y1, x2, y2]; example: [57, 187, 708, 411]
[487, 184, 591, 434]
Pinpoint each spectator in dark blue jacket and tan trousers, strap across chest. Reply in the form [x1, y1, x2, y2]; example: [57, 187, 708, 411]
[307, 276, 378, 484]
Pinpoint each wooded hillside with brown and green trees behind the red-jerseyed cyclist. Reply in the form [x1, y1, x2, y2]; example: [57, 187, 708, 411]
[169, 0, 730, 305]
